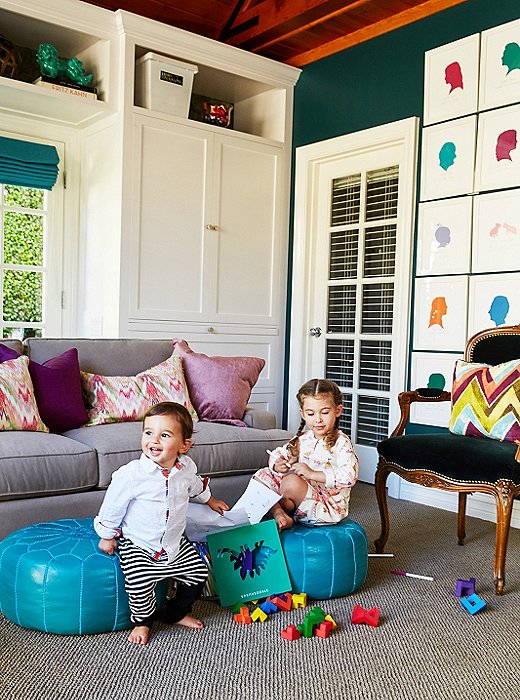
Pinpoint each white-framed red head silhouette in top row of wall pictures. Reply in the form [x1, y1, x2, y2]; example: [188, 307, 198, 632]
[423, 34, 480, 126]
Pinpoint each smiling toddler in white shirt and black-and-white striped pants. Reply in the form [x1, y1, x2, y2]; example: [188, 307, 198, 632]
[94, 402, 228, 644]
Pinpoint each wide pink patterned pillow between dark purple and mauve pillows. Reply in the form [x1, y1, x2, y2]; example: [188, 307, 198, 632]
[81, 355, 197, 425]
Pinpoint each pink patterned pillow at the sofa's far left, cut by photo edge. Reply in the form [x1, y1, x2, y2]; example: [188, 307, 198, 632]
[0, 355, 49, 433]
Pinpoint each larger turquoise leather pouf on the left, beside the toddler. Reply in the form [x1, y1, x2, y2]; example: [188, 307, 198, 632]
[0, 518, 164, 634]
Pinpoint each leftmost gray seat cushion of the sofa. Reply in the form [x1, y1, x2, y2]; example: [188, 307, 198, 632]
[0, 432, 98, 504]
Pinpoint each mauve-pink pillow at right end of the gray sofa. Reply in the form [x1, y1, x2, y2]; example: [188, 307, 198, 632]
[173, 338, 265, 426]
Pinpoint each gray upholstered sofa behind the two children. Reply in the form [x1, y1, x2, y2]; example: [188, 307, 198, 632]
[0, 338, 290, 539]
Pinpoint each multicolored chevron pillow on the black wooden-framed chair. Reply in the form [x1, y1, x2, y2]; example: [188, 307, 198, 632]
[448, 360, 520, 442]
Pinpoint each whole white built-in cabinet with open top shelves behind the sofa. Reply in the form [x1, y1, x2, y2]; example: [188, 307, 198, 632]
[0, 0, 299, 417]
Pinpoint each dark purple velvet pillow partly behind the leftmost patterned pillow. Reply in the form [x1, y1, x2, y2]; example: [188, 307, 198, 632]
[0, 343, 88, 433]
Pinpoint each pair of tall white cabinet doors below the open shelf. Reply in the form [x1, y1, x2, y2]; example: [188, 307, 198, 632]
[130, 114, 286, 333]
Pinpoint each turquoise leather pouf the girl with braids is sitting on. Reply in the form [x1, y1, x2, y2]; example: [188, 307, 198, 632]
[280, 518, 368, 600]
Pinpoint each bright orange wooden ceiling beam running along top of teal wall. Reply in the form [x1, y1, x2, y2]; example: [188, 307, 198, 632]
[284, 0, 467, 68]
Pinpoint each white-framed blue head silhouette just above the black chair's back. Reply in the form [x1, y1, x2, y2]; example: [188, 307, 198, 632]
[468, 272, 520, 338]
